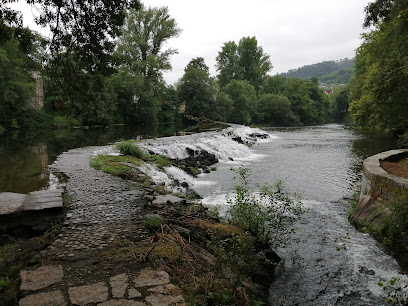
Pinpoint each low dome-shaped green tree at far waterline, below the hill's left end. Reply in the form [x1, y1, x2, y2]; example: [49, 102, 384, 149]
[258, 94, 299, 126]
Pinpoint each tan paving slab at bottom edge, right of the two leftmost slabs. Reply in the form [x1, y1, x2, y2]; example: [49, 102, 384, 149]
[68, 282, 109, 305]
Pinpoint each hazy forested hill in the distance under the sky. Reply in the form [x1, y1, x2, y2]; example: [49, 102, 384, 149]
[280, 58, 354, 84]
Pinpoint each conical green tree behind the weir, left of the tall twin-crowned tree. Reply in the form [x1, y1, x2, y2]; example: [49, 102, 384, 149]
[178, 57, 217, 119]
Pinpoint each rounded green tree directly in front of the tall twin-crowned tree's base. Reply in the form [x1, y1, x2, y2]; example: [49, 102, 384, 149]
[223, 80, 256, 124]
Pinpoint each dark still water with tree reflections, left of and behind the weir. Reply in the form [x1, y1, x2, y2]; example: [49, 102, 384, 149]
[0, 120, 194, 193]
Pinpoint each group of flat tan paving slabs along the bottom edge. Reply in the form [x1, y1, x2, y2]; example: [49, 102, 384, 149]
[19, 265, 185, 306]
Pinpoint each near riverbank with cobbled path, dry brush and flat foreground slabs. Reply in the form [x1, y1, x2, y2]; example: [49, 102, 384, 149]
[0, 147, 278, 305]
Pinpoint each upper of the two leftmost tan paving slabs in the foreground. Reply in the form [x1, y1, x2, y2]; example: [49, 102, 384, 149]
[20, 265, 64, 291]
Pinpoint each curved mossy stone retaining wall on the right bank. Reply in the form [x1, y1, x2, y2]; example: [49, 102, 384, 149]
[349, 150, 408, 270]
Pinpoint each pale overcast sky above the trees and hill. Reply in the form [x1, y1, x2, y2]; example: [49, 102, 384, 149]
[10, 0, 371, 84]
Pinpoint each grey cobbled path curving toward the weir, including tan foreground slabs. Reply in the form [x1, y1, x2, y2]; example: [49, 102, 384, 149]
[19, 147, 184, 306]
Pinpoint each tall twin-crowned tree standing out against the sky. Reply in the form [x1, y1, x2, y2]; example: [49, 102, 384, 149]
[216, 37, 272, 90]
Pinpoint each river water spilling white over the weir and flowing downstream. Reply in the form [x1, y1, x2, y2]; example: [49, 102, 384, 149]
[141, 125, 406, 305]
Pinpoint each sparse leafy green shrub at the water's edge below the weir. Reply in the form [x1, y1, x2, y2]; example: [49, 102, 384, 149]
[228, 167, 303, 248]
